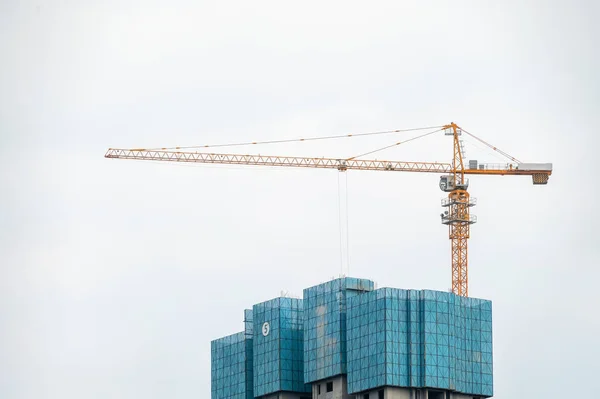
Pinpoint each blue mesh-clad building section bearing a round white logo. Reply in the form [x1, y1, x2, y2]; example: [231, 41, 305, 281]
[252, 298, 310, 397]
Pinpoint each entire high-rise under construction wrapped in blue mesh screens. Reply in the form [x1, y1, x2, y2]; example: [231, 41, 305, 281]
[211, 277, 493, 399]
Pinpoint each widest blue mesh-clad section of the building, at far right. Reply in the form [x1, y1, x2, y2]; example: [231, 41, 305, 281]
[347, 288, 493, 396]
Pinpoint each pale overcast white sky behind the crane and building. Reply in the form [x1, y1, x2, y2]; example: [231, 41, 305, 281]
[0, 0, 600, 399]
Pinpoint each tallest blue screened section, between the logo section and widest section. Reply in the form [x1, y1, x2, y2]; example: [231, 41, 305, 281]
[304, 277, 375, 383]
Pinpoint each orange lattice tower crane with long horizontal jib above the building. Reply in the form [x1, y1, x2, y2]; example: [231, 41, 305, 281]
[104, 122, 552, 297]
